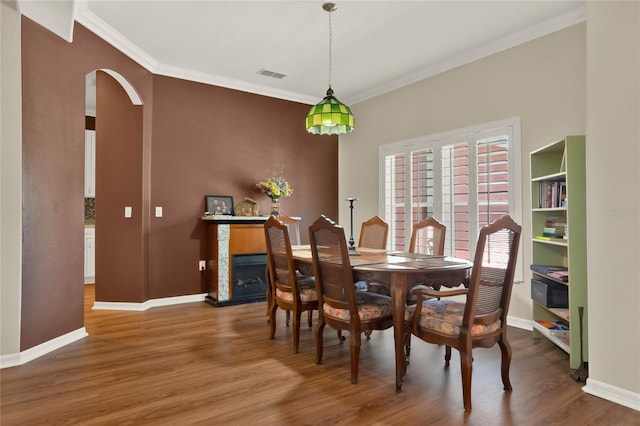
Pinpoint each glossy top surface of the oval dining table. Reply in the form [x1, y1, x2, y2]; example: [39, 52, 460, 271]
[291, 245, 473, 272]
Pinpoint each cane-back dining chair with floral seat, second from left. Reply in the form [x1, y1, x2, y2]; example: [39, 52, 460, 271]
[309, 216, 393, 384]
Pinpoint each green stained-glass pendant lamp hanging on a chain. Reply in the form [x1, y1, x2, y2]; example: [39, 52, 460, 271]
[307, 3, 354, 135]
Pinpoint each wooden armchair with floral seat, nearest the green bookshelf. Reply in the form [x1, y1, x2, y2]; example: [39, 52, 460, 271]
[405, 215, 521, 411]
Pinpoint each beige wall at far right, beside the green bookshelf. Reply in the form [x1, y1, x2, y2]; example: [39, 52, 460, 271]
[586, 2, 640, 400]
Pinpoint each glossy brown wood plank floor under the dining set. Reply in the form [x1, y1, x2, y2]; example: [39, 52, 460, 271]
[0, 285, 640, 426]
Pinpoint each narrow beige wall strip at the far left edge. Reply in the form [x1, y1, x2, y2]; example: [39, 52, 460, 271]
[0, 1, 22, 355]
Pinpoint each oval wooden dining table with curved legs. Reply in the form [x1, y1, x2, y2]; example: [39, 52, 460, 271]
[292, 246, 473, 391]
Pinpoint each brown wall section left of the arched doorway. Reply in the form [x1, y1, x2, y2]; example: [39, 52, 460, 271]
[20, 17, 84, 350]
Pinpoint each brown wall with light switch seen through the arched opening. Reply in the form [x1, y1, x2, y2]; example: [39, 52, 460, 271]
[95, 71, 147, 302]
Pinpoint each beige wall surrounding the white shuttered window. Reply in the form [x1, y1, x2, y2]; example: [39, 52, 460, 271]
[339, 24, 586, 328]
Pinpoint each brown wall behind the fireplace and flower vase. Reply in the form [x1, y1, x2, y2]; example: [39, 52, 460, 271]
[149, 76, 338, 298]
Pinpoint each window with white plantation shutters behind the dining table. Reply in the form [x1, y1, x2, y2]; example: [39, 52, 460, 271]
[380, 118, 522, 280]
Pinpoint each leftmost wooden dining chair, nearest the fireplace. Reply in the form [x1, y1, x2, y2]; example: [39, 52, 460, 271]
[264, 216, 318, 353]
